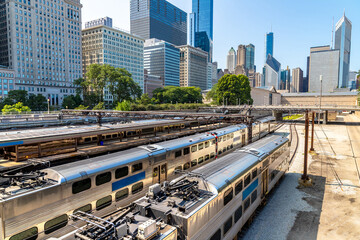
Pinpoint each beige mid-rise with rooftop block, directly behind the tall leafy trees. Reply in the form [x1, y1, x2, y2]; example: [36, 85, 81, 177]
[82, 17, 144, 102]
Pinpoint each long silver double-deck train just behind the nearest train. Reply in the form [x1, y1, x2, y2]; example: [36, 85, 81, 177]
[0, 118, 275, 240]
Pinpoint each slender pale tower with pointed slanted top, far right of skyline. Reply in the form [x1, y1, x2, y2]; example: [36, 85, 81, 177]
[335, 12, 352, 88]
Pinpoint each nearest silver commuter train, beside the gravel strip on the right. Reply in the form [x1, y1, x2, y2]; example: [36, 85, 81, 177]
[60, 134, 290, 240]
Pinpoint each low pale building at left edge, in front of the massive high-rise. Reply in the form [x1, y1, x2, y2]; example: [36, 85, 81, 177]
[0, 66, 14, 100]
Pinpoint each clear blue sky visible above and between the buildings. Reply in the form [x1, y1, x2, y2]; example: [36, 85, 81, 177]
[81, 0, 360, 72]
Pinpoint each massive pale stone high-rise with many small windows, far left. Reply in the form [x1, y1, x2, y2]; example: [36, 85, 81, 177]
[0, 0, 82, 105]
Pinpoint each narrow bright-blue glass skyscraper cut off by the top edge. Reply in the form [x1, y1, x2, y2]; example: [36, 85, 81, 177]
[190, 0, 214, 62]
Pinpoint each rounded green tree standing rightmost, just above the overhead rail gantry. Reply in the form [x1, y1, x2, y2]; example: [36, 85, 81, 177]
[214, 74, 253, 105]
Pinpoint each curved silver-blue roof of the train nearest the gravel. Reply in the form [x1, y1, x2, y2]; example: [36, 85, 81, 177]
[193, 135, 289, 192]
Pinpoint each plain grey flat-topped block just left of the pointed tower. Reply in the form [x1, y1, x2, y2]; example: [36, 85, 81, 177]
[309, 50, 340, 93]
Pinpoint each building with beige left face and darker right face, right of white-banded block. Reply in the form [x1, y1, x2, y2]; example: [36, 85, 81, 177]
[178, 45, 208, 90]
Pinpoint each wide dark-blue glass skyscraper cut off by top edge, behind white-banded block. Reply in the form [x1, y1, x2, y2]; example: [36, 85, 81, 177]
[130, 0, 187, 45]
